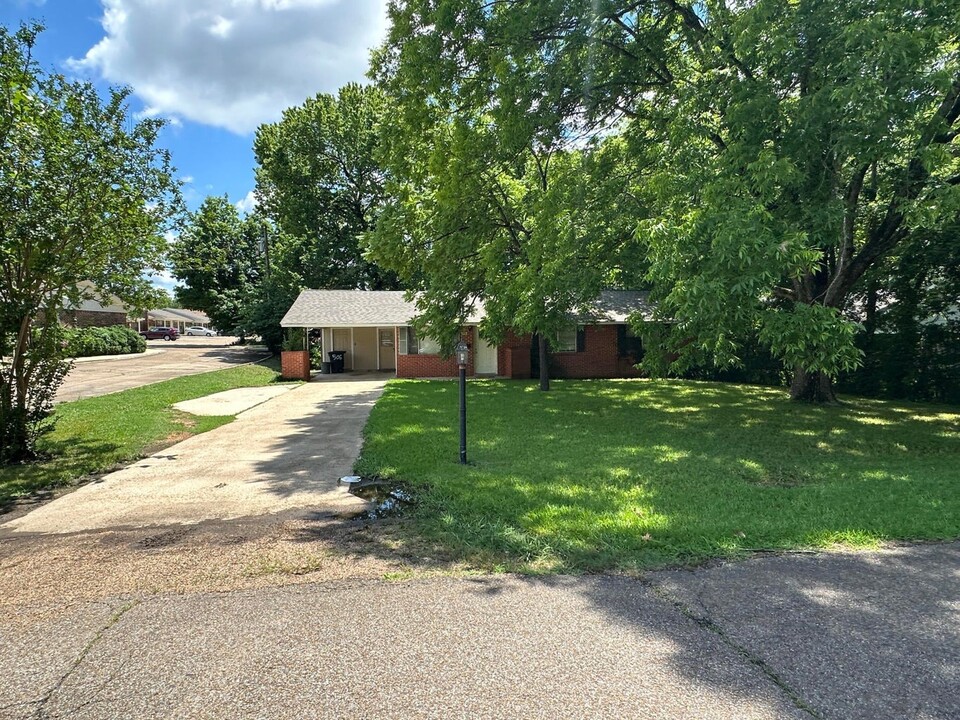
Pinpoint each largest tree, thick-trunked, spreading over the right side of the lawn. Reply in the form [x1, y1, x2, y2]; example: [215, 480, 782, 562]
[379, 0, 960, 400]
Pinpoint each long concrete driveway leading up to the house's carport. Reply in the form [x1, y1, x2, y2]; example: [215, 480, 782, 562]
[3, 377, 386, 533]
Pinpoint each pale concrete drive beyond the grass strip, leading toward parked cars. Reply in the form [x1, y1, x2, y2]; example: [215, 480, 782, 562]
[56, 337, 269, 402]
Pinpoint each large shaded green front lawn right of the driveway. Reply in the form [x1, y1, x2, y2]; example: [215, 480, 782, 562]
[356, 381, 960, 572]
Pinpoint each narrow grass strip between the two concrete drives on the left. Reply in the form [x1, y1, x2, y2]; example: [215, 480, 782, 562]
[0, 359, 292, 511]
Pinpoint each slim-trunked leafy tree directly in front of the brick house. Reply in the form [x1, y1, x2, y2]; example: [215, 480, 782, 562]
[370, 3, 642, 390]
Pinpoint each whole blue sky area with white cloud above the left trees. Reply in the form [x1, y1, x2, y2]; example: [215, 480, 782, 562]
[0, 0, 386, 219]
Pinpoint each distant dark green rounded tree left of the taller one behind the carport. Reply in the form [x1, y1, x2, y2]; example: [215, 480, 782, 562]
[169, 195, 269, 337]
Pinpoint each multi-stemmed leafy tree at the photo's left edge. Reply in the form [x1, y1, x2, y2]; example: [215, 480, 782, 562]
[0, 26, 179, 463]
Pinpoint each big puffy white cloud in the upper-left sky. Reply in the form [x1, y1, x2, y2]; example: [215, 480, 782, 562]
[71, 0, 387, 134]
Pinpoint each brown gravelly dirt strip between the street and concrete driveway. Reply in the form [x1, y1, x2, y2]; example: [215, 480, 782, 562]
[0, 513, 457, 616]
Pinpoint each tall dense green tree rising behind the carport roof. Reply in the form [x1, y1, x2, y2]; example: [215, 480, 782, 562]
[243, 84, 398, 350]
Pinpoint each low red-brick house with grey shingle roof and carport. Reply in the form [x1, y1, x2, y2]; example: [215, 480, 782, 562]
[280, 290, 653, 378]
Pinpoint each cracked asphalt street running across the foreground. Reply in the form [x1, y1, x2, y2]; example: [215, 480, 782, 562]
[0, 544, 960, 720]
